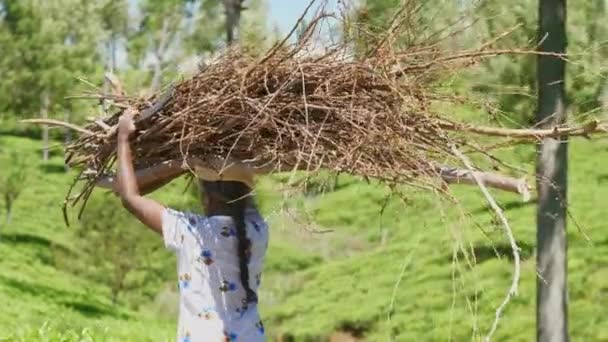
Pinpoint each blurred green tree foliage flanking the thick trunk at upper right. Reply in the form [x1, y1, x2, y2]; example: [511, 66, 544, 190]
[470, 0, 608, 125]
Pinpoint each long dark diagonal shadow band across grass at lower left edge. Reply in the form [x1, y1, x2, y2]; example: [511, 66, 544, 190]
[0, 275, 129, 319]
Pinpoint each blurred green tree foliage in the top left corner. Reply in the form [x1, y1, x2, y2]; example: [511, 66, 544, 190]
[0, 0, 101, 117]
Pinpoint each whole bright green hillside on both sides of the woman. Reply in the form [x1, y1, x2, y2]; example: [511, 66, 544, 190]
[0, 130, 608, 341]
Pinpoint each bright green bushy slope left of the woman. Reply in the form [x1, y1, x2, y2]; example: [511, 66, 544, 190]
[0, 134, 179, 341]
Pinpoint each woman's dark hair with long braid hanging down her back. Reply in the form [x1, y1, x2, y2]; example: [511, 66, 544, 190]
[199, 180, 257, 303]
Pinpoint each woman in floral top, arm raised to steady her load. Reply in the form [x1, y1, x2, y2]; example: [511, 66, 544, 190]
[114, 110, 268, 342]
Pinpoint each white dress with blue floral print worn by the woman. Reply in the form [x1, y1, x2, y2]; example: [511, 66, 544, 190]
[162, 209, 268, 342]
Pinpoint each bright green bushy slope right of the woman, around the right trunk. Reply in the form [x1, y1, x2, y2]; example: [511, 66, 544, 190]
[264, 141, 608, 341]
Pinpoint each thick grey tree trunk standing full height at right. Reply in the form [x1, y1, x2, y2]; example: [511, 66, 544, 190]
[536, 0, 569, 342]
